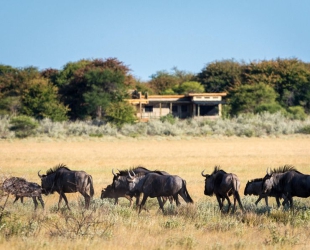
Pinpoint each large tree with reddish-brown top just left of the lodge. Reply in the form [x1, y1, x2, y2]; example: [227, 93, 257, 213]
[56, 58, 133, 120]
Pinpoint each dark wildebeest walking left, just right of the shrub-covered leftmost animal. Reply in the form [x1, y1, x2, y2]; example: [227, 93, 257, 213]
[38, 164, 94, 210]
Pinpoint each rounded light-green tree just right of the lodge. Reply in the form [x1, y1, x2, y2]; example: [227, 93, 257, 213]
[229, 83, 277, 115]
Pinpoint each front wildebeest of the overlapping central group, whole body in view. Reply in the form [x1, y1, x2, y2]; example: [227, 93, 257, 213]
[127, 171, 194, 213]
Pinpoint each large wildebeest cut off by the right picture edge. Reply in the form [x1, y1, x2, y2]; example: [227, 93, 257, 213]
[262, 165, 310, 209]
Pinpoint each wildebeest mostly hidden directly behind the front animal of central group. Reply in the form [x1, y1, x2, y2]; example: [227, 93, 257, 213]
[112, 166, 173, 207]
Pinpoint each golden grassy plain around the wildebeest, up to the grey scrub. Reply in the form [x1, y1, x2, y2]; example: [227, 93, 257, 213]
[0, 135, 310, 249]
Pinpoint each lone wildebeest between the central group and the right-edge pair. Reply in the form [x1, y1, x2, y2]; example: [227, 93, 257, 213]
[201, 166, 243, 213]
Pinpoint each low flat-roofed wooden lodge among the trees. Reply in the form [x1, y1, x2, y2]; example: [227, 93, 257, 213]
[127, 92, 226, 121]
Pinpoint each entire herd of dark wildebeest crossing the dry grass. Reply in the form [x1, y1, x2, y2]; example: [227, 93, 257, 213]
[2, 164, 310, 213]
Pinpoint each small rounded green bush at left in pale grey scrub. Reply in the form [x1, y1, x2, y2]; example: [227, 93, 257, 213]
[10, 115, 39, 138]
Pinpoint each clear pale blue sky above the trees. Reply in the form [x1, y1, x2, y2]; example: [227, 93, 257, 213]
[0, 0, 310, 80]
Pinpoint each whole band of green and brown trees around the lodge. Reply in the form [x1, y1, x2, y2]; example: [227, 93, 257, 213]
[0, 58, 310, 126]
